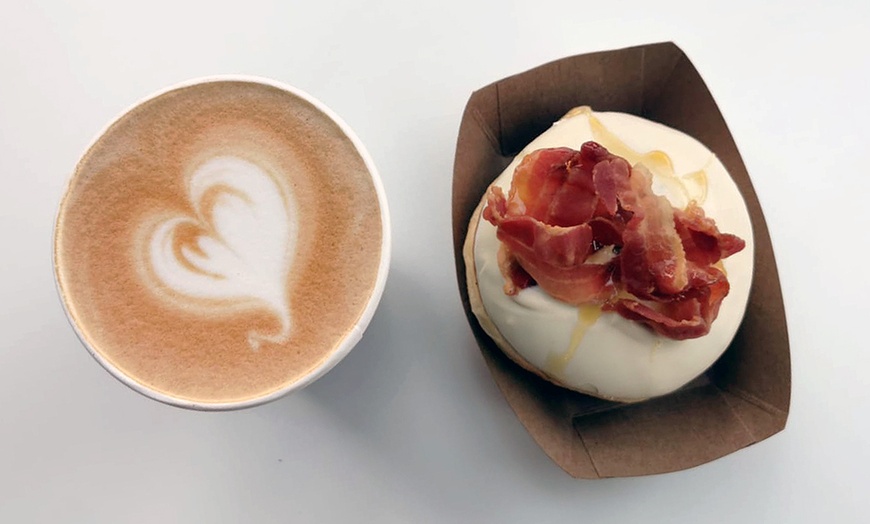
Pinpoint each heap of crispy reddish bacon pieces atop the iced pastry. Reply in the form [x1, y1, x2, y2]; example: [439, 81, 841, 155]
[483, 142, 745, 339]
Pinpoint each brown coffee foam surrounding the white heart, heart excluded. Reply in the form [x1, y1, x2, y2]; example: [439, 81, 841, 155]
[55, 81, 382, 403]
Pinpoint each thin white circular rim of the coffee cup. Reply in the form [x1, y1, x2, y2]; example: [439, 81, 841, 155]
[51, 74, 392, 411]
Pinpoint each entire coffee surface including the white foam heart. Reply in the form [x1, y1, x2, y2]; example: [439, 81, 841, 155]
[55, 80, 384, 404]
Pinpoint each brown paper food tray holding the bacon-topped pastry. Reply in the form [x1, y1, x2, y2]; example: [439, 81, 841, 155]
[453, 43, 791, 478]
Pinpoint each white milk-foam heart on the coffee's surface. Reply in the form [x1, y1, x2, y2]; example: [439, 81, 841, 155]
[140, 156, 299, 349]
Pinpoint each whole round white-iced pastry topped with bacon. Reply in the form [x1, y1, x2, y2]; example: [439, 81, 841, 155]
[464, 107, 753, 402]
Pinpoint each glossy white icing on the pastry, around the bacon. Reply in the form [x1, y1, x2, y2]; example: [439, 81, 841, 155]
[474, 113, 754, 401]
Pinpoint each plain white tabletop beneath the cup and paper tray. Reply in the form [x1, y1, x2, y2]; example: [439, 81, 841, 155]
[0, 0, 870, 523]
